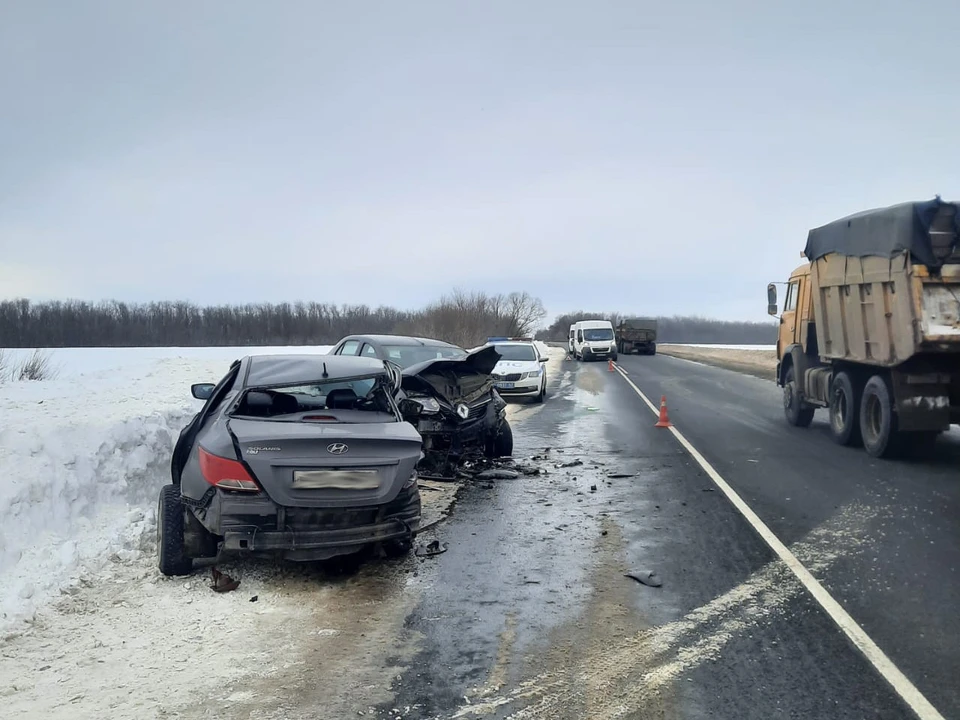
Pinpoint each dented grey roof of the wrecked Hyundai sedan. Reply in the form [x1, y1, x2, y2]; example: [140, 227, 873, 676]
[243, 353, 386, 387]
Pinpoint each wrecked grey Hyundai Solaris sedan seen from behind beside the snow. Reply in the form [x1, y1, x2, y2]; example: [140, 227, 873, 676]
[157, 355, 421, 575]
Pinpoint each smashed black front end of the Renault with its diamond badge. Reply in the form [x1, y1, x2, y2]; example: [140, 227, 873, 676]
[400, 347, 513, 480]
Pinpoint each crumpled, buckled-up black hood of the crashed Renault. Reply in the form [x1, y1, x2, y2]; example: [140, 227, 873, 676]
[401, 346, 500, 404]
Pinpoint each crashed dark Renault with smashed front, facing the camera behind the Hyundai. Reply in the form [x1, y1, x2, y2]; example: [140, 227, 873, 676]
[330, 335, 513, 479]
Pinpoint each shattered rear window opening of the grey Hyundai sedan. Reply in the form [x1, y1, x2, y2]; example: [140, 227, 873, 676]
[233, 374, 392, 418]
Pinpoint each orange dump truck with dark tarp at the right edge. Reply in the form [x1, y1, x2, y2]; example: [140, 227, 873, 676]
[767, 197, 960, 457]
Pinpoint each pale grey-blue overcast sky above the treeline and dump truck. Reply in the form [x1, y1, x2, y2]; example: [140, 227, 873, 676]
[0, 0, 960, 320]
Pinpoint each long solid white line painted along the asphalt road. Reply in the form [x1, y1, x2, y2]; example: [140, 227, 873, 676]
[614, 365, 945, 720]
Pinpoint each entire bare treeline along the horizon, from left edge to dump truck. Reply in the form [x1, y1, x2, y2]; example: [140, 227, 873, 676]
[0, 290, 776, 348]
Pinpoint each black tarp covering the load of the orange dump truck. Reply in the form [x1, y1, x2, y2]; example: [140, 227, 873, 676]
[804, 197, 960, 267]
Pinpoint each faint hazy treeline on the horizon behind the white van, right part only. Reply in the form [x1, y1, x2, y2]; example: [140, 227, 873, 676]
[537, 310, 777, 345]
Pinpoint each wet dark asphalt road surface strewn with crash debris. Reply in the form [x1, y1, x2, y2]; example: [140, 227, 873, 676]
[377, 356, 960, 720]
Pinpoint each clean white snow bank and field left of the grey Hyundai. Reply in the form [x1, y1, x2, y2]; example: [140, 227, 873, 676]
[0, 347, 329, 634]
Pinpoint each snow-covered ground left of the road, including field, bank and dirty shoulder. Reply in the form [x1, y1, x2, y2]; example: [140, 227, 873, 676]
[0, 347, 563, 720]
